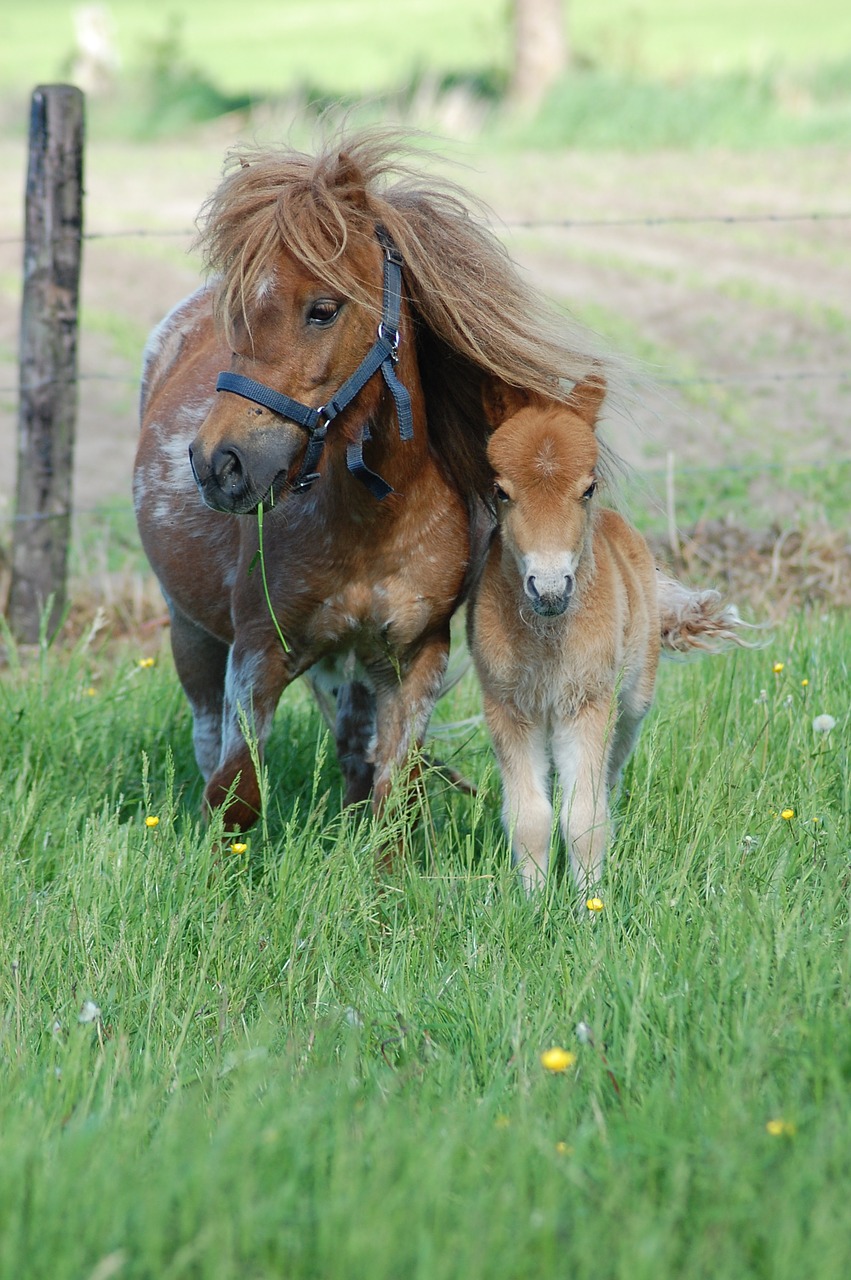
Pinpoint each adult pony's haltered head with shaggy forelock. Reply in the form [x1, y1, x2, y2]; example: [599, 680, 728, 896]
[189, 144, 416, 513]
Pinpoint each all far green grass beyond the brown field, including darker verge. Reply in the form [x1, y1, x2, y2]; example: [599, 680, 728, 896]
[0, 0, 851, 150]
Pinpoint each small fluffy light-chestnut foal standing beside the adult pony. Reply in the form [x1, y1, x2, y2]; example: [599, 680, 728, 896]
[468, 375, 741, 892]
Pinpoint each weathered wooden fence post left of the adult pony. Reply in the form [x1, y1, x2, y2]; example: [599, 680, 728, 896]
[8, 84, 83, 644]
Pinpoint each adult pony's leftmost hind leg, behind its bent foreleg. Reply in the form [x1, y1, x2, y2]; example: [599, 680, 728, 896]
[168, 600, 230, 782]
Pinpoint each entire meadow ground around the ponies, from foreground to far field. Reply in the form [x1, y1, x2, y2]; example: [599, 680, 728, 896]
[0, 0, 851, 1280]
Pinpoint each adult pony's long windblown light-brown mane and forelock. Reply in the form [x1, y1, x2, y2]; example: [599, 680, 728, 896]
[198, 128, 614, 494]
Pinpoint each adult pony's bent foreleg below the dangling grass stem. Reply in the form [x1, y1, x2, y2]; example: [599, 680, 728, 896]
[203, 637, 290, 831]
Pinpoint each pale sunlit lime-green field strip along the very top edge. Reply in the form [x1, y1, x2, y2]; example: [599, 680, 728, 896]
[6, 0, 851, 95]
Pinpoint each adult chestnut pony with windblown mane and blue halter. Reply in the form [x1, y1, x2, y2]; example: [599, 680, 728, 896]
[134, 131, 604, 828]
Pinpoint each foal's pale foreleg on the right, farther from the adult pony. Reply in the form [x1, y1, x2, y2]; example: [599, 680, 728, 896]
[553, 703, 614, 893]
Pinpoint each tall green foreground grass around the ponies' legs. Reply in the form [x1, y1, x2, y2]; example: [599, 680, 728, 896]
[0, 601, 851, 1280]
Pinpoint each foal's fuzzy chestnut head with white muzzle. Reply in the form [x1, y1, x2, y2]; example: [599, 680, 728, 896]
[488, 376, 605, 617]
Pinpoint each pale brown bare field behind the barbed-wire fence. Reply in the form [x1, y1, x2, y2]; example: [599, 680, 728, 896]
[0, 140, 851, 521]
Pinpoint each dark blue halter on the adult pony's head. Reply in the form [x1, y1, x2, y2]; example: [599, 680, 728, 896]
[216, 227, 413, 500]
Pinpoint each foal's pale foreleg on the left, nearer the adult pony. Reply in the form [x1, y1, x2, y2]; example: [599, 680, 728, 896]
[484, 695, 553, 893]
